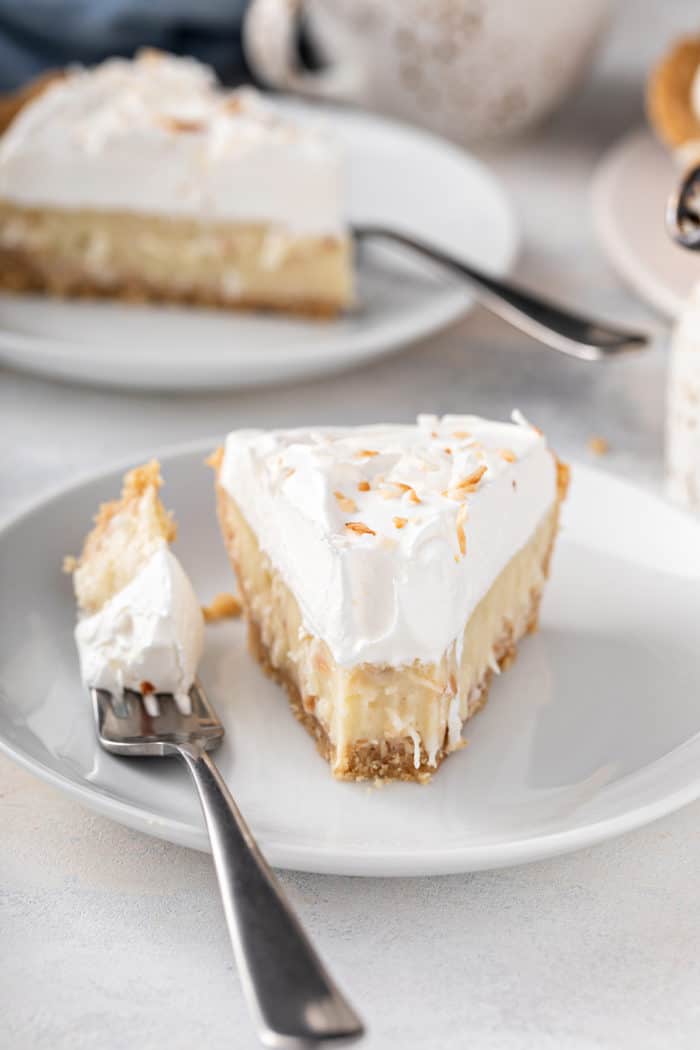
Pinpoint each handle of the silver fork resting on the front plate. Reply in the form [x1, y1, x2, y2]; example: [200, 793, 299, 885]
[177, 744, 363, 1048]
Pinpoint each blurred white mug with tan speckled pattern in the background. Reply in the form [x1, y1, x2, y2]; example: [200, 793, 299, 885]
[243, 0, 612, 142]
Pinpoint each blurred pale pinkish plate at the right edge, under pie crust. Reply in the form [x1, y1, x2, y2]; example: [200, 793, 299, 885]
[593, 131, 700, 318]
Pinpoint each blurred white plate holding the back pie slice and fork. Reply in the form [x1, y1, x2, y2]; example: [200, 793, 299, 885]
[0, 103, 517, 391]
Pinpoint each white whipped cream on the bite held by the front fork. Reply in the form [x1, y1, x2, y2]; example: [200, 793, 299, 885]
[76, 542, 204, 712]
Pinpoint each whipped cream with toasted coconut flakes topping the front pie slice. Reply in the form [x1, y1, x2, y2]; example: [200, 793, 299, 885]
[220, 416, 556, 667]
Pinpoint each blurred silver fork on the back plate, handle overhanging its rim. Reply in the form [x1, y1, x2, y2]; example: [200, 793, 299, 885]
[353, 225, 651, 361]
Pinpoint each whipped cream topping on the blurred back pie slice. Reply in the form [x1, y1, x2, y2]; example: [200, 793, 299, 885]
[0, 51, 342, 235]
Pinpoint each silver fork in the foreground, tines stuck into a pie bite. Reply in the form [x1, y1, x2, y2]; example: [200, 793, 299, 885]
[90, 683, 364, 1048]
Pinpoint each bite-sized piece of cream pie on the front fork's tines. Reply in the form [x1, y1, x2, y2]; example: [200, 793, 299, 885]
[66, 461, 204, 713]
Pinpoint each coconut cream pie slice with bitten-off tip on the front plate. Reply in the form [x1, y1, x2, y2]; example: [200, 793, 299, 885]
[214, 416, 567, 780]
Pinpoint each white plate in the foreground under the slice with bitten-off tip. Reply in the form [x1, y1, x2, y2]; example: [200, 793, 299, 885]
[0, 446, 700, 875]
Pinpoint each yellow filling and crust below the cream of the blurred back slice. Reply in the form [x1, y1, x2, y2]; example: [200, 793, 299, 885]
[0, 201, 352, 315]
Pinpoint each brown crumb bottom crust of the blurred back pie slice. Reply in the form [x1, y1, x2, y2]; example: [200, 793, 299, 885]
[0, 248, 343, 320]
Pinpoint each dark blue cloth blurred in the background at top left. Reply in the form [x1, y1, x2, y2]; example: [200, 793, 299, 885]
[0, 0, 250, 91]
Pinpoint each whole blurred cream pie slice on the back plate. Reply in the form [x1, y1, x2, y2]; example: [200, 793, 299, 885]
[0, 51, 352, 314]
